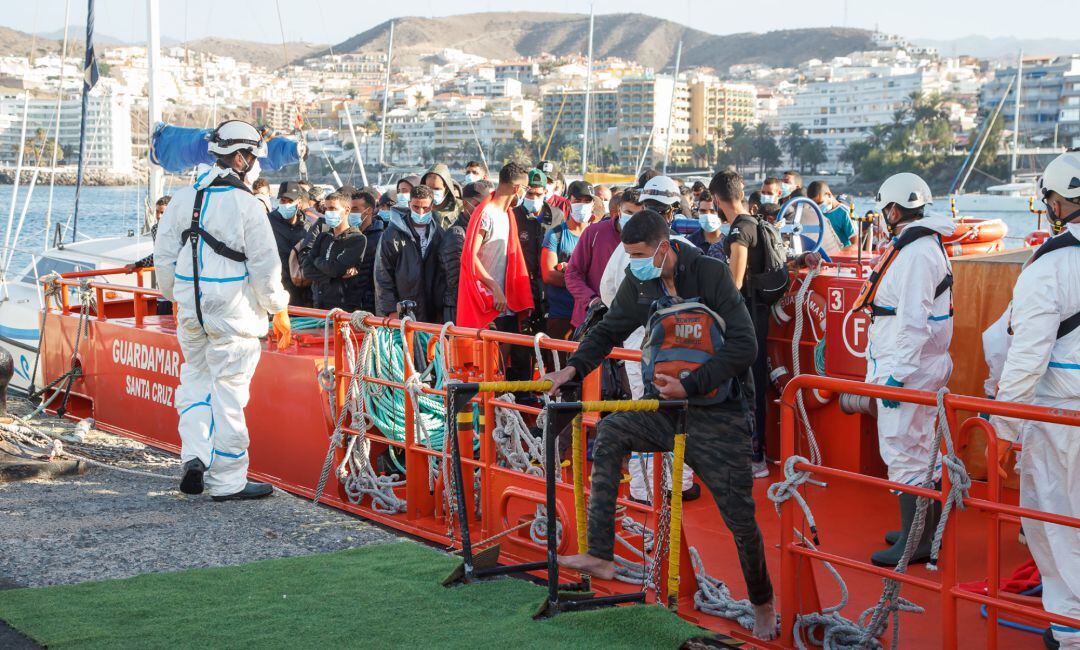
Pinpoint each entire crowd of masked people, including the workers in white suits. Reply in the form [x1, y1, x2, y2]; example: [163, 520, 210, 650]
[147, 121, 1080, 647]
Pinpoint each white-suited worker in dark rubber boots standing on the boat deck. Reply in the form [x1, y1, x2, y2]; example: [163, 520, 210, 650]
[859, 173, 956, 566]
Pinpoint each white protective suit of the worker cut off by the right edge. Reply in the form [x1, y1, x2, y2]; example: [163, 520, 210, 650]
[990, 224, 1080, 649]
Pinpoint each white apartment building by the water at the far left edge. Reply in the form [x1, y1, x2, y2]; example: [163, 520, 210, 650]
[0, 83, 133, 174]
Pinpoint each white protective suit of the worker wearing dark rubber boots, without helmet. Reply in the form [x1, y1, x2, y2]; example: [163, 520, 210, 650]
[866, 215, 956, 485]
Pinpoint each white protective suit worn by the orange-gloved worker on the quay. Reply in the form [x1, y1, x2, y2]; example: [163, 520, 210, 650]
[153, 165, 288, 497]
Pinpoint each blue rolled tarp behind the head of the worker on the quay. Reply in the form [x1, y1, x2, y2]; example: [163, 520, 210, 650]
[150, 122, 301, 174]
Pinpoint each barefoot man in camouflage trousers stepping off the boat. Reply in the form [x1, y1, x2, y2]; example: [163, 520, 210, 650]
[544, 209, 777, 639]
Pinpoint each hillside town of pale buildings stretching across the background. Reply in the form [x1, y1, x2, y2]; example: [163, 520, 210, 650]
[0, 24, 1080, 182]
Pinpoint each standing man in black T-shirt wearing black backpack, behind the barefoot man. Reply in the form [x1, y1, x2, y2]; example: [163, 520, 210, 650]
[708, 172, 787, 478]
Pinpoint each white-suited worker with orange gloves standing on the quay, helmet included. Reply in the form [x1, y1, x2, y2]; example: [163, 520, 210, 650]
[153, 120, 289, 501]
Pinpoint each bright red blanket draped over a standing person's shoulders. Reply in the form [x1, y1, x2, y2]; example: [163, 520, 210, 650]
[456, 194, 534, 329]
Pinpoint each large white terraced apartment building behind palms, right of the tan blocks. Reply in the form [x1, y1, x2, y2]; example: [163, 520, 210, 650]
[777, 70, 942, 170]
